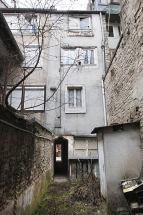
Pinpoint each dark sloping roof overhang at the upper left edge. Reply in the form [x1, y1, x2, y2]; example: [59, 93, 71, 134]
[0, 11, 24, 61]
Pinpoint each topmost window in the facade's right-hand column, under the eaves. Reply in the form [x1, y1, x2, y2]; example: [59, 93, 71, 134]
[69, 16, 91, 35]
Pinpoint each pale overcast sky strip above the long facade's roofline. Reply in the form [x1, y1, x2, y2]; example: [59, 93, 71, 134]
[5, 0, 88, 10]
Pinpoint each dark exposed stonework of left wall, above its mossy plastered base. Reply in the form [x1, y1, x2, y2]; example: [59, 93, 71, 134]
[0, 106, 52, 214]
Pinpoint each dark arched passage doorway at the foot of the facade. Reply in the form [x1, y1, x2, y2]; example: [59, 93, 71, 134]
[54, 137, 68, 175]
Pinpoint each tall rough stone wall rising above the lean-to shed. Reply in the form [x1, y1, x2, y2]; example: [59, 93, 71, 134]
[104, 0, 143, 134]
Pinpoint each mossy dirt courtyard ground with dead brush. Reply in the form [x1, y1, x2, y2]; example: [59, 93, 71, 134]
[34, 182, 108, 215]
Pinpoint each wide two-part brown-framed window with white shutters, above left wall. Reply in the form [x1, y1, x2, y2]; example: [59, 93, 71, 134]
[8, 86, 46, 112]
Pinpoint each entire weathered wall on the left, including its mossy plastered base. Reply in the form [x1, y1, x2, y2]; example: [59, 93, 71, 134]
[0, 106, 52, 215]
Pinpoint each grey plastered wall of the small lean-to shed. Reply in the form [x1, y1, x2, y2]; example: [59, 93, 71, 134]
[99, 123, 142, 215]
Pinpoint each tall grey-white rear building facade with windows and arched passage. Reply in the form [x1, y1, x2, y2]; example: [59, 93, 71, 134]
[1, 9, 105, 180]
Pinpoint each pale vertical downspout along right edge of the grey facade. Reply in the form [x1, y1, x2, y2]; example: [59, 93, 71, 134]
[100, 12, 107, 126]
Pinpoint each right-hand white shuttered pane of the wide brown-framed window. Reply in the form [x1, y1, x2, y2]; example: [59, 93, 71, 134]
[24, 87, 44, 110]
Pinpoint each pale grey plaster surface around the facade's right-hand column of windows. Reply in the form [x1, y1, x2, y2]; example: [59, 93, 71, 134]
[45, 14, 104, 135]
